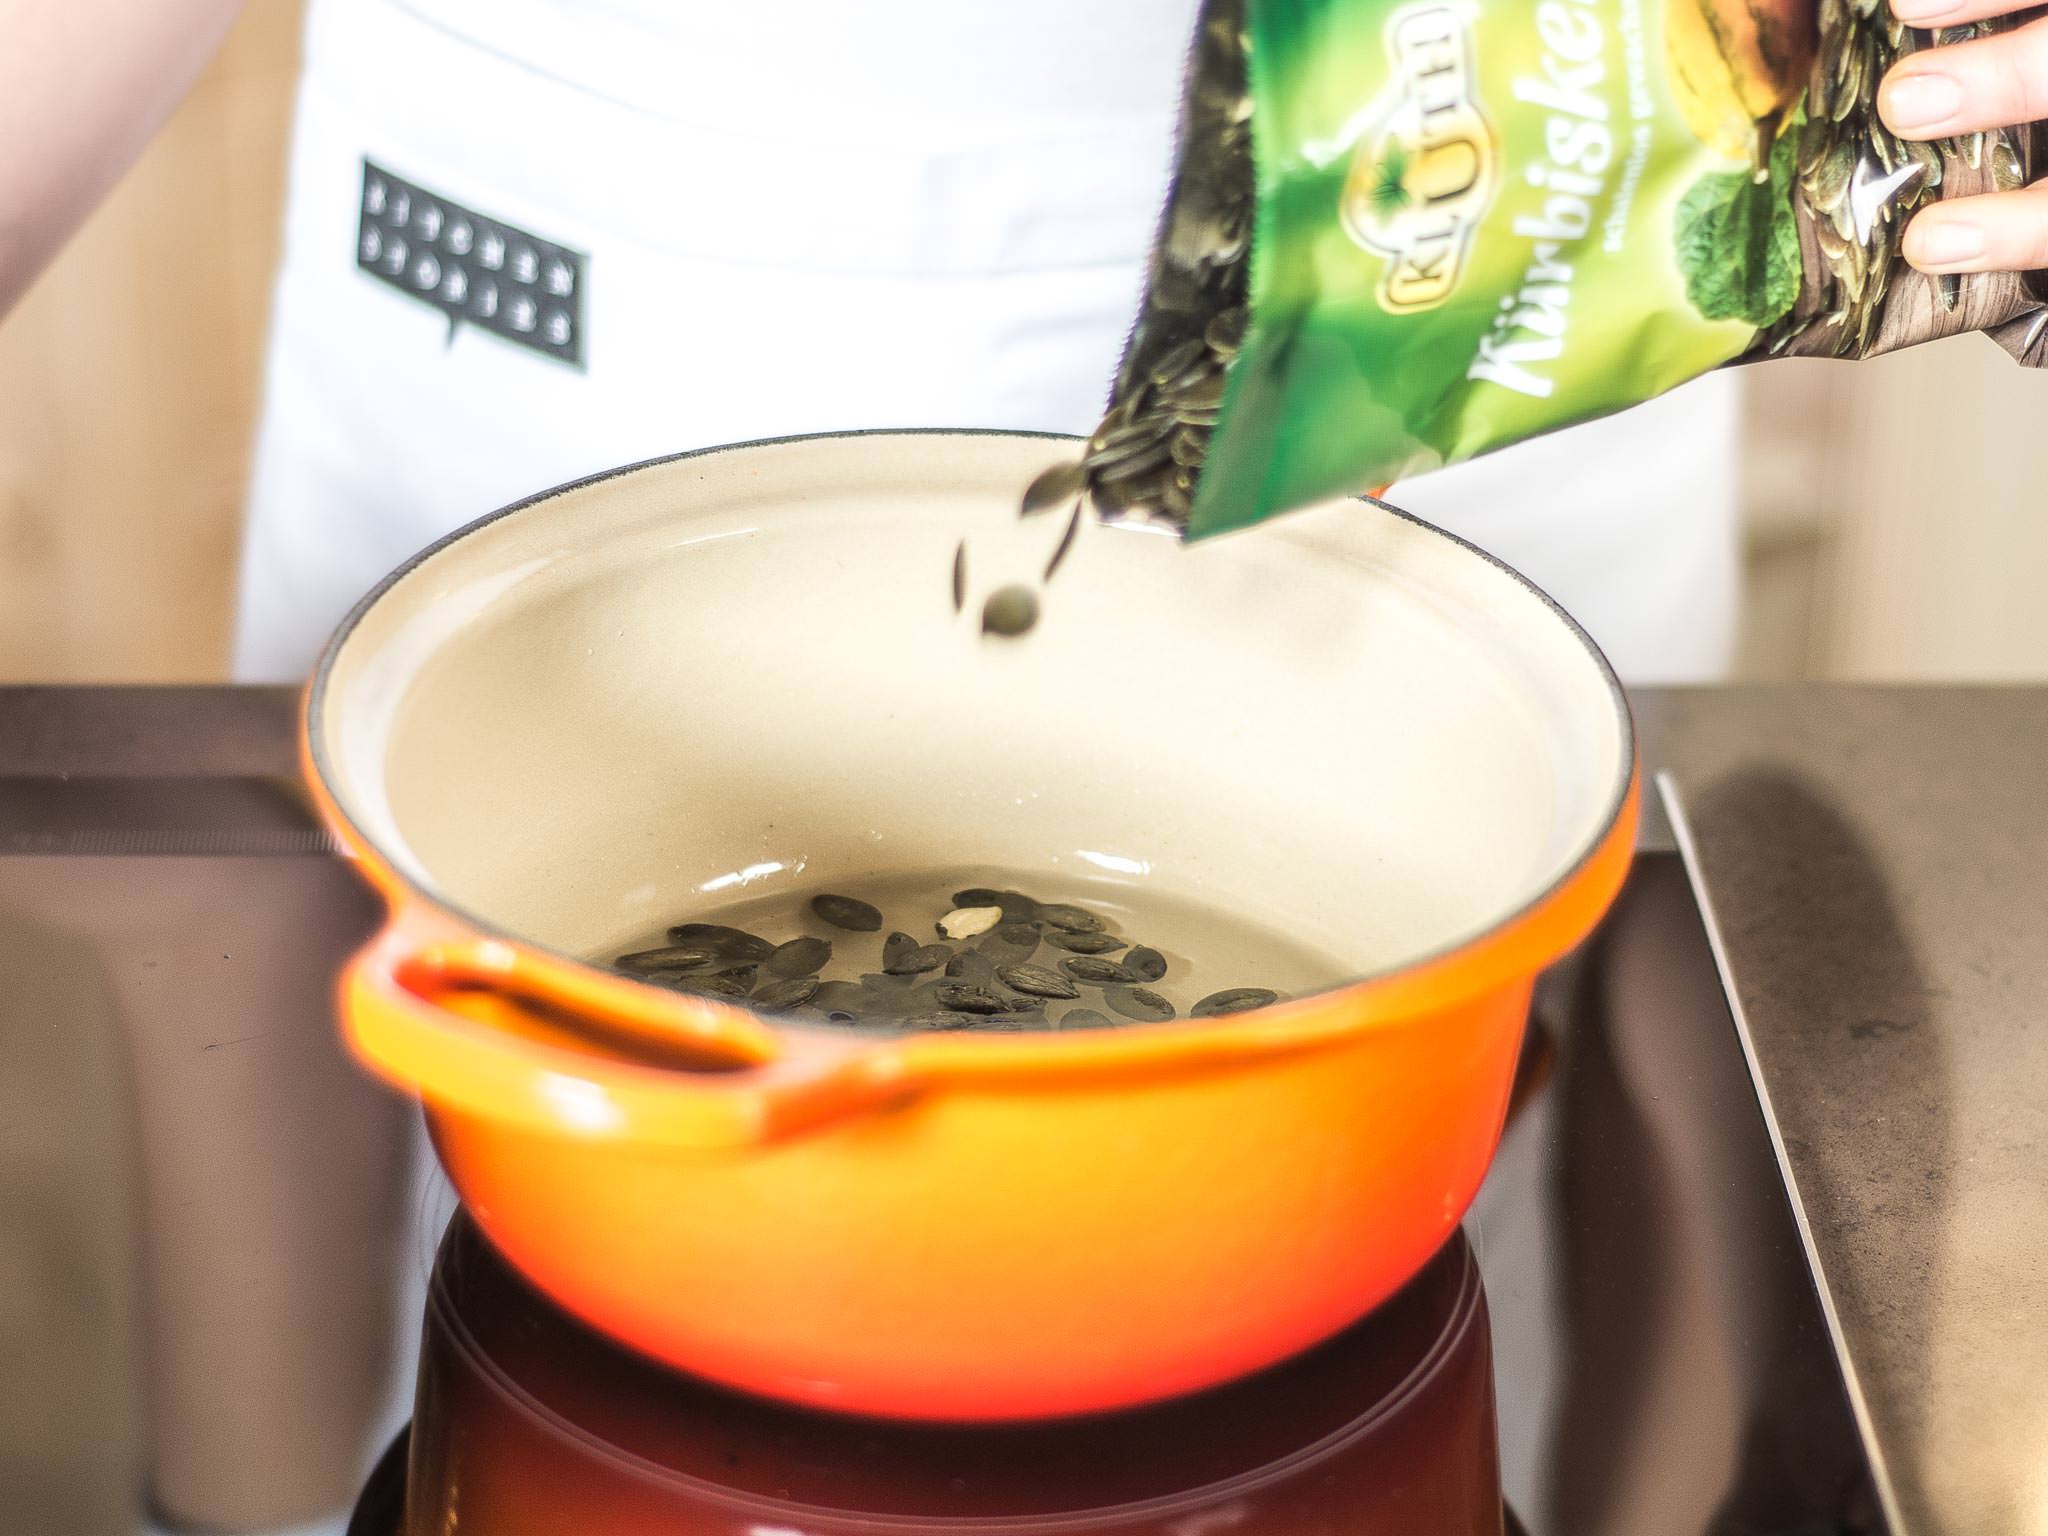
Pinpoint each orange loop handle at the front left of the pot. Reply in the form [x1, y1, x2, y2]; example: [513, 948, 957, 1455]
[342, 918, 920, 1151]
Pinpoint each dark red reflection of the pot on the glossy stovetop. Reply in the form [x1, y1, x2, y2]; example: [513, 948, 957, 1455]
[360, 1217, 1501, 1536]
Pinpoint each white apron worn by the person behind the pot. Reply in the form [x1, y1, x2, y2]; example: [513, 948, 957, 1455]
[236, 0, 1737, 680]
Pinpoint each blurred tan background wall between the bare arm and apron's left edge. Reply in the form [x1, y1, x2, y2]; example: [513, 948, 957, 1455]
[0, 0, 299, 682]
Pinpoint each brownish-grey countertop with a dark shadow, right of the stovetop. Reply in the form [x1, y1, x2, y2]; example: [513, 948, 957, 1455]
[1636, 686, 2048, 1536]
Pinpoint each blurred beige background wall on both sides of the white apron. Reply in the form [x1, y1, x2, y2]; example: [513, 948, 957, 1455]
[0, 0, 2048, 682]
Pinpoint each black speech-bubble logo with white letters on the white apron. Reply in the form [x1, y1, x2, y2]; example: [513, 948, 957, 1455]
[356, 160, 590, 369]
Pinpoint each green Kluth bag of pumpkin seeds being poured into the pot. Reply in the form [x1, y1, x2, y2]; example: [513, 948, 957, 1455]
[1083, 0, 2048, 539]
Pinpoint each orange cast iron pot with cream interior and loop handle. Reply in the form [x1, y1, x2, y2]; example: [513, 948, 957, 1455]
[305, 434, 1638, 1419]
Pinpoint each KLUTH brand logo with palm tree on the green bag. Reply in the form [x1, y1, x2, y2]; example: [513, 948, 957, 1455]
[1341, 4, 1499, 311]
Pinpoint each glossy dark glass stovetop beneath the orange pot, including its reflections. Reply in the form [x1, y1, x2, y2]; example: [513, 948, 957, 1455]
[0, 694, 1882, 1536]
